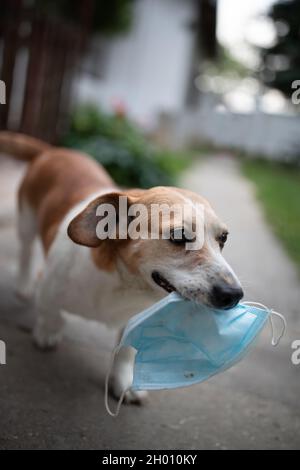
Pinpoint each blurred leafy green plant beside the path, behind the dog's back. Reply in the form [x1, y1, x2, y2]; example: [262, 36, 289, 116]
[62, 104, 190, 188]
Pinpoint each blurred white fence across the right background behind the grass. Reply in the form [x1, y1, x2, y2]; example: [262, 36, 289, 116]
[168, 108, 300, 160]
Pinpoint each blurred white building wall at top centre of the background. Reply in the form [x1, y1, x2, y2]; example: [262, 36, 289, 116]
[76, 0, 194, 123]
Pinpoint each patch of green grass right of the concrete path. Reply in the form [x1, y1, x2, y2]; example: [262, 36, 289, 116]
[242, 160, 300, 272]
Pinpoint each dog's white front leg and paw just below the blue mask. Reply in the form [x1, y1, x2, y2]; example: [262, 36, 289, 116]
[111, 332, 148, 405]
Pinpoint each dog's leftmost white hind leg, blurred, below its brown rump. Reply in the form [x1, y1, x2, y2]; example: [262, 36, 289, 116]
[16, 201, 37, 299]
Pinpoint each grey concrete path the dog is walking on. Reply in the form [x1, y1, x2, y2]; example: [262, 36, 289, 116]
[0, 156, 300, 449]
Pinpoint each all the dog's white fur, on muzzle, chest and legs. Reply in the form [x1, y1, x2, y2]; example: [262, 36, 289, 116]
[19, 190, 239, 401]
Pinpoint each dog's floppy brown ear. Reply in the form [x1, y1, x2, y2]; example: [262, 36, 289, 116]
[68, 192, 133, 248]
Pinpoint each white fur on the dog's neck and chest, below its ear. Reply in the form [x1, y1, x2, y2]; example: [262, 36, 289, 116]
[44, 195, 163, 327]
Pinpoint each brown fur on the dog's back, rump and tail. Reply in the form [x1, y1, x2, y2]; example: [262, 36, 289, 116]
[0, 132, 115, 252]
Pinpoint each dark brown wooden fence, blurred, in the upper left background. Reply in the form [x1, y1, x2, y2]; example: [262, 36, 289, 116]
[0, 0, 86, 143]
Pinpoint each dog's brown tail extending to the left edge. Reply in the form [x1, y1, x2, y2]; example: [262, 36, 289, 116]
[0, 131, 51, 162]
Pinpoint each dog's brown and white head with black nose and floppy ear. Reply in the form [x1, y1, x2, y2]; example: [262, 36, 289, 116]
[68, 187, 243, 308]
